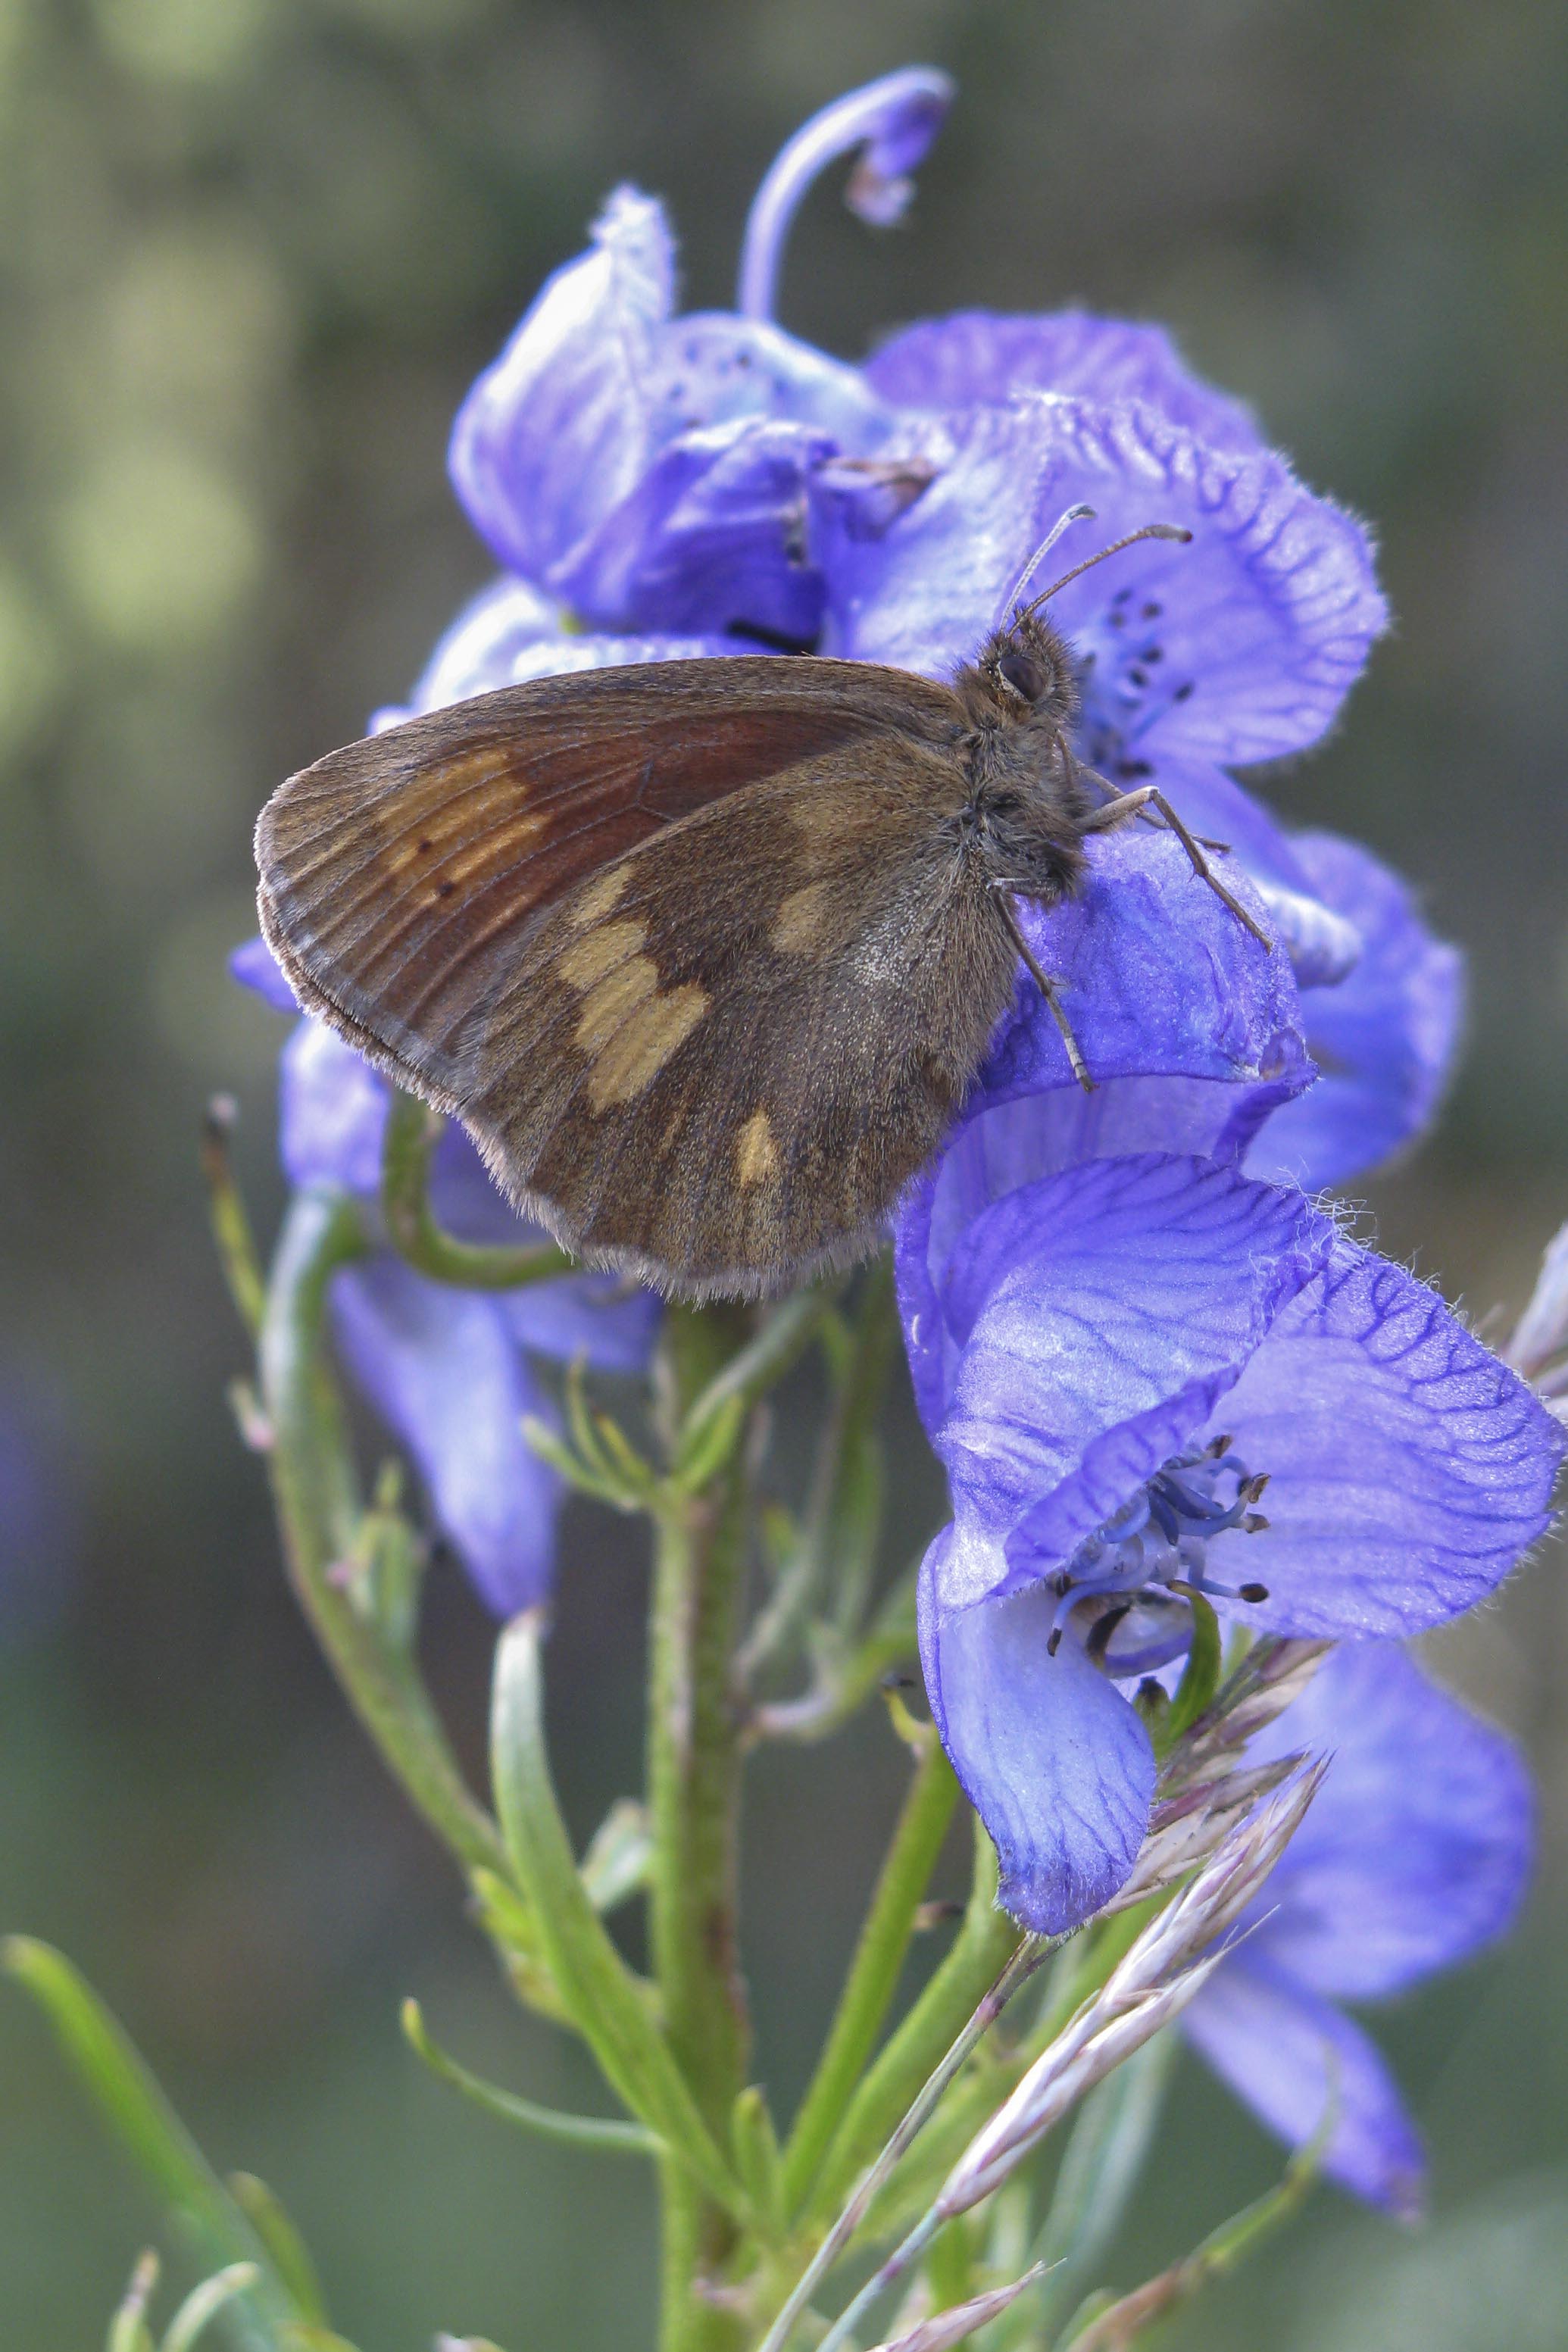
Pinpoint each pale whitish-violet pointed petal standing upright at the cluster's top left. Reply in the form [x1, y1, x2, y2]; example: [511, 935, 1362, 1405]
[447, 188, 675, 586]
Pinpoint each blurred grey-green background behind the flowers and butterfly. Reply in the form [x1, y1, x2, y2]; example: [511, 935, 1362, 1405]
[0, 0, 1568, 2352]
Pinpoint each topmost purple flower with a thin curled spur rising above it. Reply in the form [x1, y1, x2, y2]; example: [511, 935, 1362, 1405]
[451, 68, 950, 642]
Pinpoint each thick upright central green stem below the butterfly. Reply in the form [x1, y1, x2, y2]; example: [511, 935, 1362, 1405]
[646, 1307, 750, 2352]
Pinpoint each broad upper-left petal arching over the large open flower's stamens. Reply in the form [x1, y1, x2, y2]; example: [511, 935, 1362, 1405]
[933, 1152, 1333, 1571]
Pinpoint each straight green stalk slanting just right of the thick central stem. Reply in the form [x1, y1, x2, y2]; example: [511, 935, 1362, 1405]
[782, 1726, 959, 2213]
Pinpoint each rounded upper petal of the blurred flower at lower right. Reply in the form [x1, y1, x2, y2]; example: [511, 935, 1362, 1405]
[1242, 1641, 1535, 1999]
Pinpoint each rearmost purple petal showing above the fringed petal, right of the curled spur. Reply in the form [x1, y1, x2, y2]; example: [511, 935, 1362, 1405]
[865, 311, 1263, 449]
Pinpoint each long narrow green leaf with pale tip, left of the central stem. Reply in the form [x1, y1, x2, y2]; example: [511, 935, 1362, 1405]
[492, 1611, 745, 2218]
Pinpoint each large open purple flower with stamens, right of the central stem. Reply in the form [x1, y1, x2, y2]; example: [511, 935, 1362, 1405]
[901, 1152, 1563, 1933]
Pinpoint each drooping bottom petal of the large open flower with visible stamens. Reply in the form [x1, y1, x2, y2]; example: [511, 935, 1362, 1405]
[919, 1526, 1154, 1935]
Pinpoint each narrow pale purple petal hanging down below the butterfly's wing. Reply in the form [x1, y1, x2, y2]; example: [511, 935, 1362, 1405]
[332, 1256, 560, 1616]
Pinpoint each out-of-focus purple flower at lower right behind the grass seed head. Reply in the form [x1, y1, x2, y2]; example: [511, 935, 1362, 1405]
[1185, 1641, 1532, 2216]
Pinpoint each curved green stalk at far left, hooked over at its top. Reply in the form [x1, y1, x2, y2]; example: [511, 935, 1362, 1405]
[261, 1185, 510, 1877]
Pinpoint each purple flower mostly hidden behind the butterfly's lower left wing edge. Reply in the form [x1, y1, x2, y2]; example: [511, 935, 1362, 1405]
[235, 941, 658, 1616]
